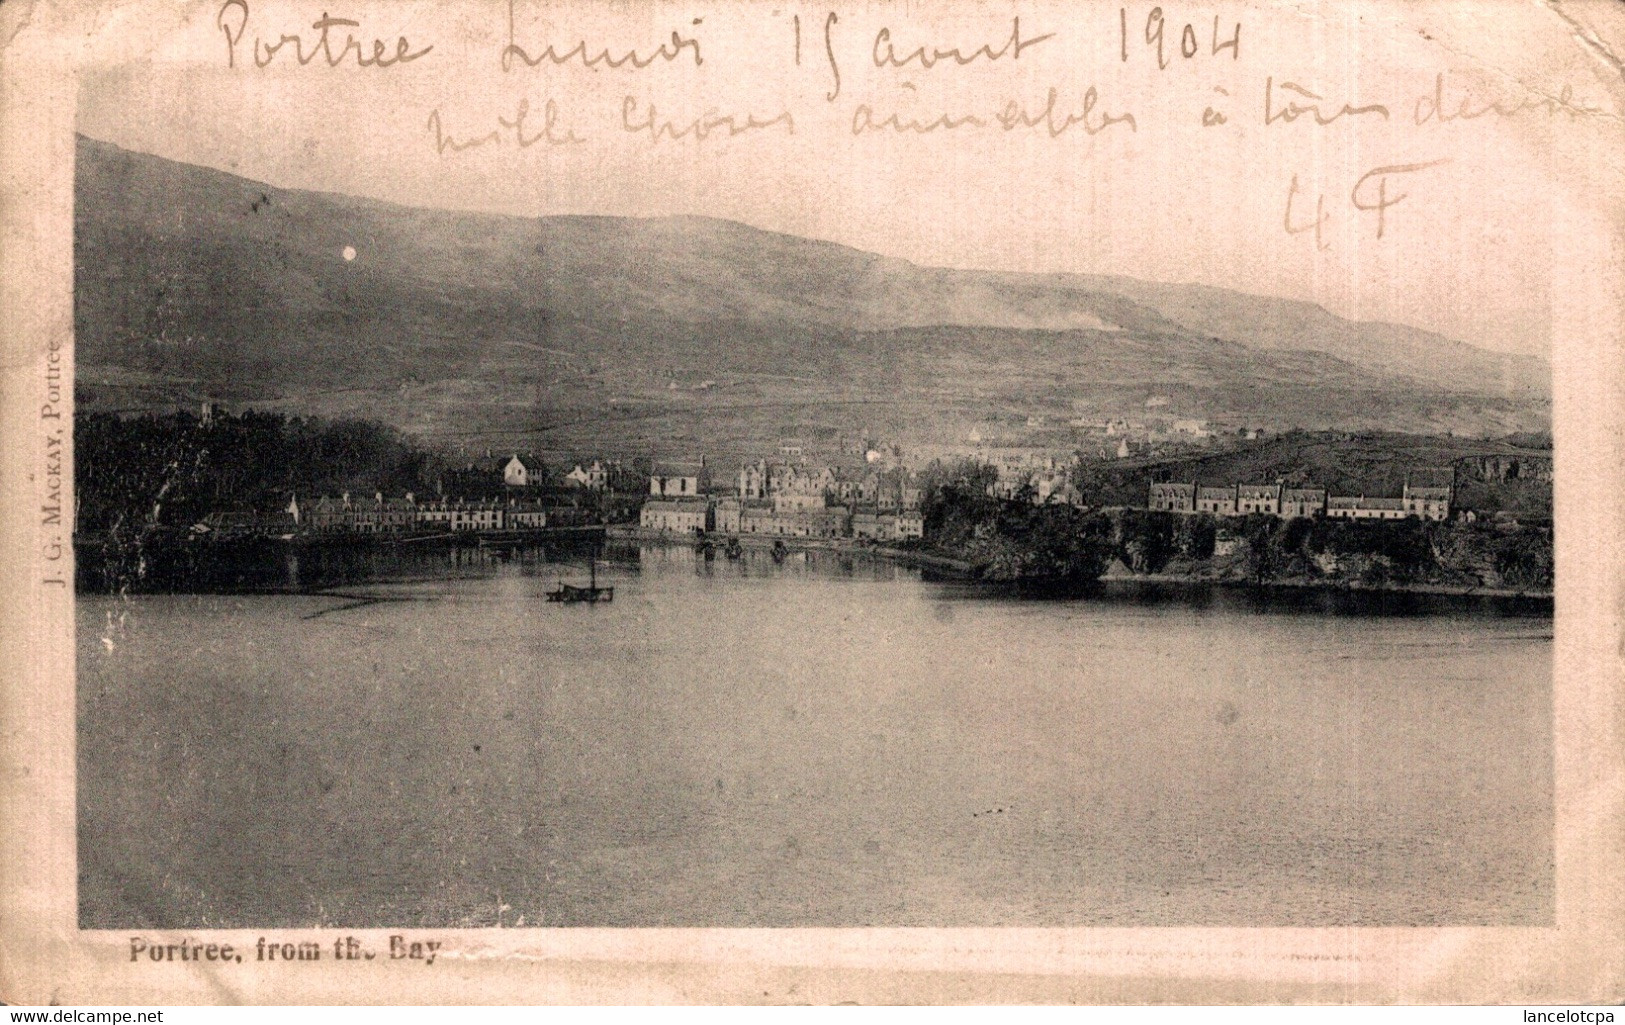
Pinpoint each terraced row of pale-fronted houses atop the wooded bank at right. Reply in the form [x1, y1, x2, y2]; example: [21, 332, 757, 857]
[1146, 481, 1454, 520]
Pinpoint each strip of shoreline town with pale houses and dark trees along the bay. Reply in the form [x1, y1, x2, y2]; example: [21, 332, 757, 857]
[78, 411, 1552, 595]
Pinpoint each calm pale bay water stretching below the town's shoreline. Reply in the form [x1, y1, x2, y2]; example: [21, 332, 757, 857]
[78, 547, 1554, 928]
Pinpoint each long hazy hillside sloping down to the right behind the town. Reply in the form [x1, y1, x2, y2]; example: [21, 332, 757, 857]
[75, 138, 1550, 452]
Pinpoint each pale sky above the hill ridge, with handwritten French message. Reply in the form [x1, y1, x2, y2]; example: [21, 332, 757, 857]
[76, 0, 1620, 356]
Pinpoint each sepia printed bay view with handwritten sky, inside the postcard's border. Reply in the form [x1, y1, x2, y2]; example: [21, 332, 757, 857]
[3, 0, 1622, 1001]
